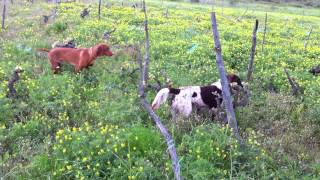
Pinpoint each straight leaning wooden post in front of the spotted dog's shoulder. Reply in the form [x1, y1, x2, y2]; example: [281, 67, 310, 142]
[211, 12, 241, 140]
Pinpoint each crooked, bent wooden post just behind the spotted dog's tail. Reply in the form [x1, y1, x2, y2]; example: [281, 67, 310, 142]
[138, 1, 182, 180]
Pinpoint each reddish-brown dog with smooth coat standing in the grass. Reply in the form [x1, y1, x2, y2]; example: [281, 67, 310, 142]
[38, 44, 113, 74]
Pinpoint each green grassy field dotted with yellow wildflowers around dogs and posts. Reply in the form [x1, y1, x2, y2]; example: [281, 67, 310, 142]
[0, 1, 320, 179]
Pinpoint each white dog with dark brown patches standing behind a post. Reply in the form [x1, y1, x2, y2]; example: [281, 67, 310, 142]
[152, 74, 243, 121]
